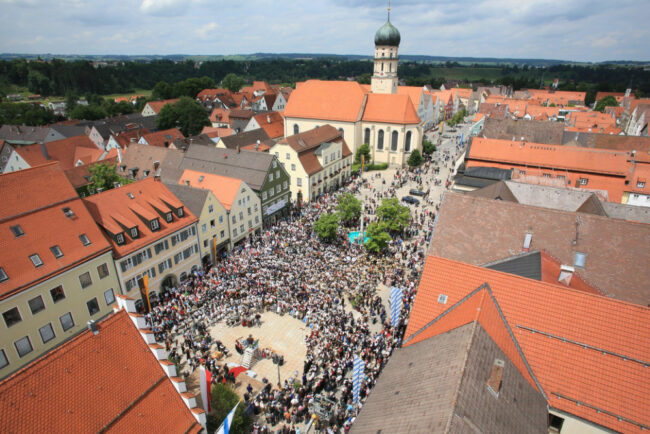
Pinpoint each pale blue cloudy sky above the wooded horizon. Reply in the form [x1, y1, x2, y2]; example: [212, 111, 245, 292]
[0, 0, 650, 61]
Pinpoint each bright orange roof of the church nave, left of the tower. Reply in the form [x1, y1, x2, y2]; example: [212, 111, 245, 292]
[284, 80, 366, 122]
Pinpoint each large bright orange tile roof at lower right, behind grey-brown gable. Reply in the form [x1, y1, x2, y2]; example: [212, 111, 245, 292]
[405, 256, 650, 432]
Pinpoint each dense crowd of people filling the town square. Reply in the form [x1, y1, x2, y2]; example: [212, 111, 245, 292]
[146, 171, 435, 433]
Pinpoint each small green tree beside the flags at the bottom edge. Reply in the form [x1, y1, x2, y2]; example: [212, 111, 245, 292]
[207, 383, 251, 434]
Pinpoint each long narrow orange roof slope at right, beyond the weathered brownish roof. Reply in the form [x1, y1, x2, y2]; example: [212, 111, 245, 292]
[468, 137, 629, 176]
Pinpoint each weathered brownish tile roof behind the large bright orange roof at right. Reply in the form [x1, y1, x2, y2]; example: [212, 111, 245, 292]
[429, 193, 650, 306]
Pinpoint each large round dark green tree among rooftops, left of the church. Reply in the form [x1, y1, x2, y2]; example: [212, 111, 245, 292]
[156, 96, 210, 137]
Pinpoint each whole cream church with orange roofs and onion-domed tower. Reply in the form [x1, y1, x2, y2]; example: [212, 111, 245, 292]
[284, 9, 423, 166]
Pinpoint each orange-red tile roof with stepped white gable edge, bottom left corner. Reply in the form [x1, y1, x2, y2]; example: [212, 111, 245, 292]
[0, 311, 201, 433]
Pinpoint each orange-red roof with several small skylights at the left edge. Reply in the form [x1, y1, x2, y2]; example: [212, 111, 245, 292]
[0, 163, 110, 298]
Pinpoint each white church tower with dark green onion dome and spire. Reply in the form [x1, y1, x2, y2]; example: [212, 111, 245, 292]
[370, 5, 400, 93]
